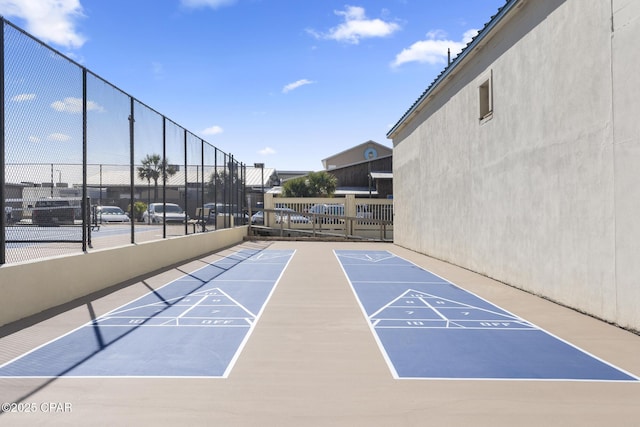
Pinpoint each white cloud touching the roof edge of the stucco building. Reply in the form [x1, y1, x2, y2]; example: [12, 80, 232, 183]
[391, 30, 478, 67]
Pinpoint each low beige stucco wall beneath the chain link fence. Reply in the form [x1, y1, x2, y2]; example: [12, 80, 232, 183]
[0, 226, 247, 326]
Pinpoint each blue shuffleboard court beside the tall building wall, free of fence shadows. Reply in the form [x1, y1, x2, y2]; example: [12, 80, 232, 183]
[335, 250, 639, 381]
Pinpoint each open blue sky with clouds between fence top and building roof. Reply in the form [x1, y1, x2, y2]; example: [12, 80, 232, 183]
[0, 0, 505, 170]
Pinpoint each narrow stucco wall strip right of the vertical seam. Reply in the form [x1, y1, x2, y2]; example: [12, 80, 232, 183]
[611, 0, 640, 330]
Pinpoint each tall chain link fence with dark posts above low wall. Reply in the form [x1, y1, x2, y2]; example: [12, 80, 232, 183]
[0, 19, 246, 264]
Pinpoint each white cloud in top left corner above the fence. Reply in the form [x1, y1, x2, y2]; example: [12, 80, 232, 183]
[0, 0, 86, 48]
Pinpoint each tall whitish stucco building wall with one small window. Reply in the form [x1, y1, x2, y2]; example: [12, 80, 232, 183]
[391, 0, 640, 330]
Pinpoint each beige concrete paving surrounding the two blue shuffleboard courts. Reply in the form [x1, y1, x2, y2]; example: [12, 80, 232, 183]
[0, 242, 640, 427]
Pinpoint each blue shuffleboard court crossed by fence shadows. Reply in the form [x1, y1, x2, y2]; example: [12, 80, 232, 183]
[0, 250, 294, 377]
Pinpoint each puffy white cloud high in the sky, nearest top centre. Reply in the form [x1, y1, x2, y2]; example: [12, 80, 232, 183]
[307, 6, 400, 44]
